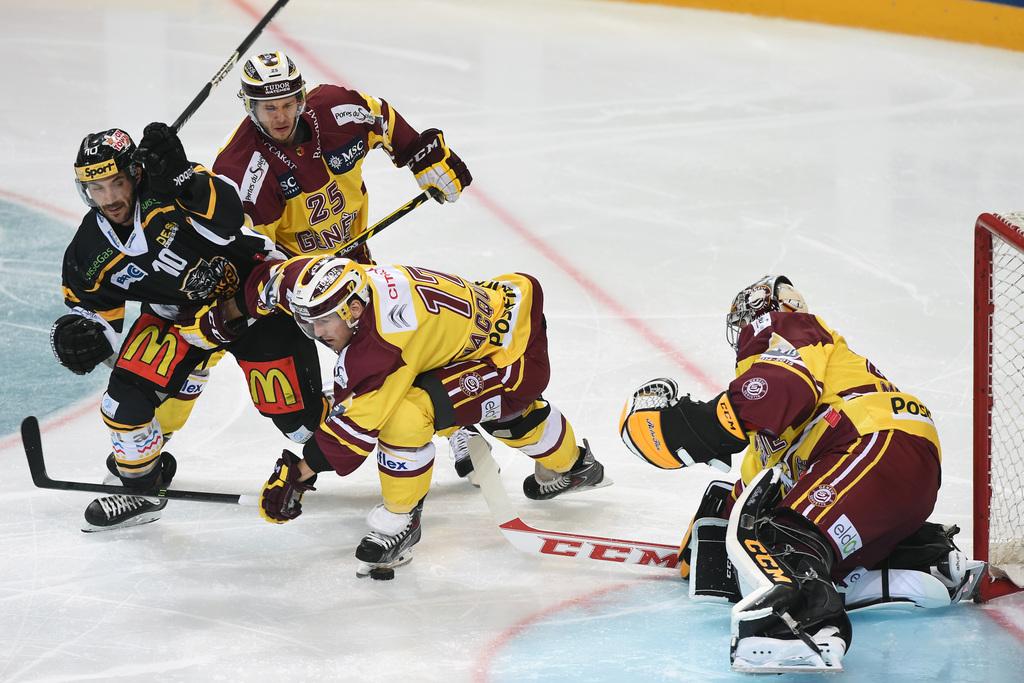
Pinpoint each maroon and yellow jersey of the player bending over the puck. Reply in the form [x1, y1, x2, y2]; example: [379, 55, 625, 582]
[247, 257, 540, 473]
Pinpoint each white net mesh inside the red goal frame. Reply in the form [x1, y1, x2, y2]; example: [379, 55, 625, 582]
[989, 213, 1024, 569]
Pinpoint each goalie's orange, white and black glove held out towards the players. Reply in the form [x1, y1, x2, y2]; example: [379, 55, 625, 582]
[618, 378, 748, 472]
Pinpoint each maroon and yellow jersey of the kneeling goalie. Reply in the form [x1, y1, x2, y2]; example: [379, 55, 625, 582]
[729, 312, 941, 489]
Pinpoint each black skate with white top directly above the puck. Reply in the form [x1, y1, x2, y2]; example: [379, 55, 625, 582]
[355, 500, 423, 579]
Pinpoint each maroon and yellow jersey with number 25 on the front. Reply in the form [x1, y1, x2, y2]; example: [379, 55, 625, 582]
[213, 85, 418, 256]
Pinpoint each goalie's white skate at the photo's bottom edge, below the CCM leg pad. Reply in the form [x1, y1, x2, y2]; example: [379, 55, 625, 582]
[729, 626, 846, 674]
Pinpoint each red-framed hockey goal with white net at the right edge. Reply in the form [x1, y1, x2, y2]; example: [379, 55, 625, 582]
[974, 212, 1024, 599]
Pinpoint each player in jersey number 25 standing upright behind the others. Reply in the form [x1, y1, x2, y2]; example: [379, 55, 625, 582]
[213, 50, 485, 477]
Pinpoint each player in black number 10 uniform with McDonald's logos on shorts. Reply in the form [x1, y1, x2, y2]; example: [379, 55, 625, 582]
[50, 123, 327, 530]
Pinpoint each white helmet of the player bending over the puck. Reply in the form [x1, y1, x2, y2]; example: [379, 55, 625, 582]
[291, 256, 370, 338]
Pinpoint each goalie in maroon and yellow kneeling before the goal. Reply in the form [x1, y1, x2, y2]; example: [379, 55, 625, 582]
[620, 275, 982, 673]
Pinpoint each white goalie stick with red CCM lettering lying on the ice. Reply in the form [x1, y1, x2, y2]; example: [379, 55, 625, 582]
[469, 440, 679, 570]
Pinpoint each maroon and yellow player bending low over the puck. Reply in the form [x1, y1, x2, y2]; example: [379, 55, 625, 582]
[246, 256, 609, 575]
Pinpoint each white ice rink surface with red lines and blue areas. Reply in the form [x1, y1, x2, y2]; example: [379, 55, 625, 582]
[0, 0, 1024, 682]
